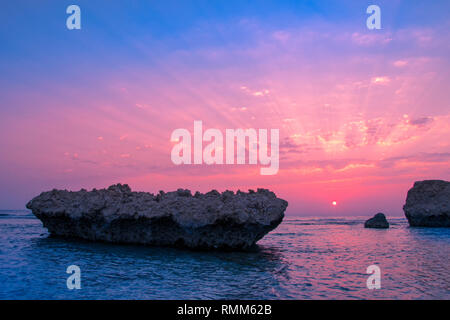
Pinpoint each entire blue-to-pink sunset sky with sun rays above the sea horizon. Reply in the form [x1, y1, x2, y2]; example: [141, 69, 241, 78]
[0, 0, 450, 217]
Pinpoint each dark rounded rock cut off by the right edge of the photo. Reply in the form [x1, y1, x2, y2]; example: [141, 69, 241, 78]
[403, 180, 450, 227]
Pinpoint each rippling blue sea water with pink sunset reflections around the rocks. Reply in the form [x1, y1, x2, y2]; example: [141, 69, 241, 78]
[0, 211, 450, 299]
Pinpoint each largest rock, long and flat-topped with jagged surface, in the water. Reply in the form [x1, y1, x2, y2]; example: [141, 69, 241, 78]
[27, 184, 288, 249]
